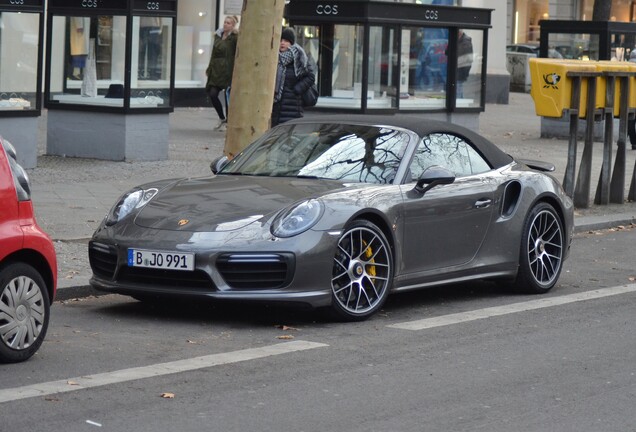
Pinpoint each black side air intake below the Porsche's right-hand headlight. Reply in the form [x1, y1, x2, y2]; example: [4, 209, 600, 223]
[216, 253, 294, 289]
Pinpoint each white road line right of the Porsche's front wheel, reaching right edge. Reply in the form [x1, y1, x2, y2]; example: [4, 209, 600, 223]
[387, 284, 636, 330]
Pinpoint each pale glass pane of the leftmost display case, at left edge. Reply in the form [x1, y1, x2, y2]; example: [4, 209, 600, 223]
[0, 12, 40, 111]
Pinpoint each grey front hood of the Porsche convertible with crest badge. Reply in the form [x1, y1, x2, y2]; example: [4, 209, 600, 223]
[135, 175, 343, 232]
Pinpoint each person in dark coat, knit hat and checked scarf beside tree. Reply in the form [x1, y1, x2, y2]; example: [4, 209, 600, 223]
[271, 27, 316, 127]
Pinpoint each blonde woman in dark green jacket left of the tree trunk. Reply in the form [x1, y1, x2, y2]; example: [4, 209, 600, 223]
[205, 16, 238, 129]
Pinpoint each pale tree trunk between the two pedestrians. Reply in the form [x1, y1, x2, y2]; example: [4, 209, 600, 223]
[223, 0, 285, 159]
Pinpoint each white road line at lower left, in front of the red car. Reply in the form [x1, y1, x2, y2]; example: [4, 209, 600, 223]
[0, 340, 329, 403]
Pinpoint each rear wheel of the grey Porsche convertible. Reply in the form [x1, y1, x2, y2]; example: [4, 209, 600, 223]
[515, 203, 565, 294]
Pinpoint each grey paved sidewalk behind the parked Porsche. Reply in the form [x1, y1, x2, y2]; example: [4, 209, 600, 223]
[28, 93, 636, 300]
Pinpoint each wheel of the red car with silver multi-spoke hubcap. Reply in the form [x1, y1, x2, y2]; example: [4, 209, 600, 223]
[0, 263, 50, 363]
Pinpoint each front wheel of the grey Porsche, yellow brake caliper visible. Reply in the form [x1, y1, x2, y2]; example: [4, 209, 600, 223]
[331, 220, 393, 321]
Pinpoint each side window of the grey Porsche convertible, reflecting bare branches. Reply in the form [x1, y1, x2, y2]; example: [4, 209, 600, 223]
[410, 133, 490, 181]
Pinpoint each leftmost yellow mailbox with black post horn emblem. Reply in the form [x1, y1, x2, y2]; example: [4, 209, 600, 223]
[529, 58, 605, 118]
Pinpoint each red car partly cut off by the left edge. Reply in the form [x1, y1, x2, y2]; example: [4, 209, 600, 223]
[0, 138, 57, 363]
